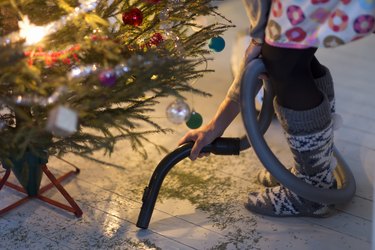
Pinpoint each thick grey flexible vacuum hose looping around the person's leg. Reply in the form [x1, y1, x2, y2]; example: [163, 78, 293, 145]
[240, 59, 356, 204]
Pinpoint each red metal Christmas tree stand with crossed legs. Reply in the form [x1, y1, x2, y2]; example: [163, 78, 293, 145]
[0, 164, 83, 217]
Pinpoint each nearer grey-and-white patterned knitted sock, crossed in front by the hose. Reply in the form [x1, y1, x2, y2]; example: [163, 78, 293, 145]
[245, 98, 334, 217]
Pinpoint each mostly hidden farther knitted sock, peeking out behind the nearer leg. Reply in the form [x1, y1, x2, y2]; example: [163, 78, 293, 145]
[257, 65, 340, 187]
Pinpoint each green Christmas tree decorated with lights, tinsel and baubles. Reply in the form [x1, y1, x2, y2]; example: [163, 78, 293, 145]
[0, 0, 230, 165]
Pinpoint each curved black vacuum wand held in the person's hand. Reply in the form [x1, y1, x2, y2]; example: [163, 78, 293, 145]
[137, 138, 241, 229]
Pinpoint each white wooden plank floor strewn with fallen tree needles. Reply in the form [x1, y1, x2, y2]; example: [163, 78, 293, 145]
[0, 0, 375, 249]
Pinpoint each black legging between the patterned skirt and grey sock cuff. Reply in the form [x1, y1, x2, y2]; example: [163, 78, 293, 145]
[262, 43, 325, 110]
